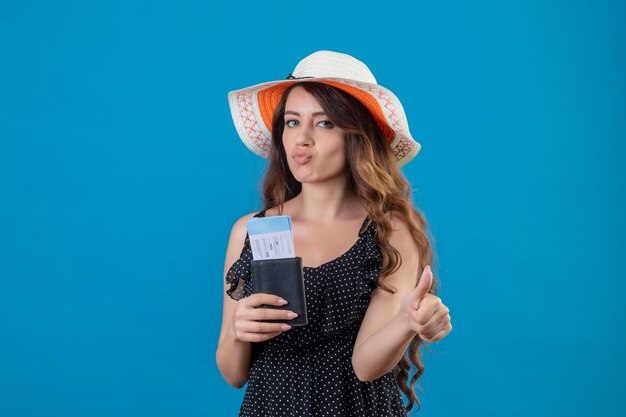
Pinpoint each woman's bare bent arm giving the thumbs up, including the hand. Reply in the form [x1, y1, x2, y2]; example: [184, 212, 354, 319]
[352, 216, 451, 382]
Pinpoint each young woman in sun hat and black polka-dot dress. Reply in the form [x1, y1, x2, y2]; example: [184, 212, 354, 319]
[216, 51, 452, 416]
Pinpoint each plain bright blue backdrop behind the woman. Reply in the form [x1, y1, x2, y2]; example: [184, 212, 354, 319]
[0, 0, 626, 417]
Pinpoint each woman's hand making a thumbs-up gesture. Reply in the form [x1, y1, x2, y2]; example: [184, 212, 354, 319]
[400, 265, 452, 342]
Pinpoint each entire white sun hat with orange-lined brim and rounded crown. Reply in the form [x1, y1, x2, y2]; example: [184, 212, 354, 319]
[228, 51, 421, 166]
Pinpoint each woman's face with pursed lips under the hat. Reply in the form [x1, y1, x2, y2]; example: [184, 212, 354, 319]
[283, 87, 348, 183]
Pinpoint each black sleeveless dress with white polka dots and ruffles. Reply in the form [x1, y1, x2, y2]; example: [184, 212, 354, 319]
[226, 210, 407, 417]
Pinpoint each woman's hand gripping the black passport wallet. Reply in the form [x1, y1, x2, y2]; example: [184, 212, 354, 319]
[230, 293, 298, 342]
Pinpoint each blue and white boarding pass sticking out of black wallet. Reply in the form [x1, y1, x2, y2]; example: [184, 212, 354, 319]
[246, 216, 296, 260]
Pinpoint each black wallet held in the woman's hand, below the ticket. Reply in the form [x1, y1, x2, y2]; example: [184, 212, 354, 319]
[251, 256, 308, 326]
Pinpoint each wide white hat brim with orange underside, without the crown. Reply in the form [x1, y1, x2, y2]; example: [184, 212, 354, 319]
[228, 78, 421, 166]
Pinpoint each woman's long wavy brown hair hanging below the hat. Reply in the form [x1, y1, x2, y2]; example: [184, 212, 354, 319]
[262, 82, 439, 411]
